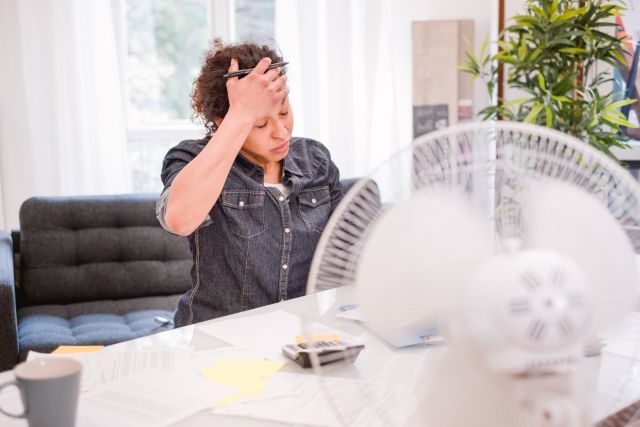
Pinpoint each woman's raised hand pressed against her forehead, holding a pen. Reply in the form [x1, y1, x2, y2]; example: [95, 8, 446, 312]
[227, 58, 288, 122]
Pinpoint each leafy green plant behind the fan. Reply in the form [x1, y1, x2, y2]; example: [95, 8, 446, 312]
[460, 0, 635, 158]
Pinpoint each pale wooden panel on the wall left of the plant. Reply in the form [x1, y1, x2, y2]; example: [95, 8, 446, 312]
[412, 20, 473, 138]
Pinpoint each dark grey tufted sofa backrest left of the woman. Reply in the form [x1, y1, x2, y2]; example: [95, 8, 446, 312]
[20, 195, 192, 304]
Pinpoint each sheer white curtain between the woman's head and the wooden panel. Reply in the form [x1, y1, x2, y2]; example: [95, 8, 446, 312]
[276, 0, 411, 177]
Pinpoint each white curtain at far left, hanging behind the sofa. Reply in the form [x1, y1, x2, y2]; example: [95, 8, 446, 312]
[0, 0, 130, 228]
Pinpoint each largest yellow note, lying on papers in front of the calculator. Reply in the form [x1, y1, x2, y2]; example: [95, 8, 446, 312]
[199, 359, 284, 406]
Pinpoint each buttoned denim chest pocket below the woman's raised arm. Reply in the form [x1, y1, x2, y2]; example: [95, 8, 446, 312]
[222, 190, 266, 238]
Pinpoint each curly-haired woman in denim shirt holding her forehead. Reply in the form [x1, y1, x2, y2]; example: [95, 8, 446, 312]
[157, 41, 342, 327]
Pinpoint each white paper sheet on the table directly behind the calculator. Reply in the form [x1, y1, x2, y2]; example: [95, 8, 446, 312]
[196, 310, 355, 363]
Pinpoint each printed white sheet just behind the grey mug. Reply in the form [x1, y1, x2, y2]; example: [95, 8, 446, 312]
[27, 348, 192, 391]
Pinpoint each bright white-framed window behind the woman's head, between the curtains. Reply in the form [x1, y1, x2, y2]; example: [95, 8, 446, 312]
[116, 0, 275, 192]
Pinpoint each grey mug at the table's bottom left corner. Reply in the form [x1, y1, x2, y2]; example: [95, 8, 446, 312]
[0, 357, 82, 427]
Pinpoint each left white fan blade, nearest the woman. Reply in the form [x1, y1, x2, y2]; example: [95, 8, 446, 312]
[356, 187, 493, 327]
